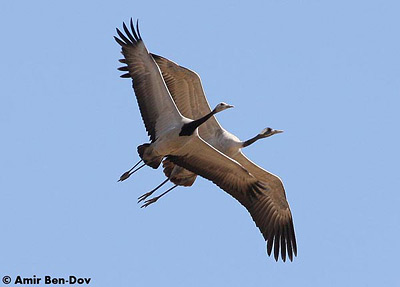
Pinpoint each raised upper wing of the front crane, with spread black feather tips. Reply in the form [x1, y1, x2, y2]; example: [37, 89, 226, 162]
[114, 19, 182, 142]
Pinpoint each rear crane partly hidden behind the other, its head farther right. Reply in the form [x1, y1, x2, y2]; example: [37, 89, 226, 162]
[152, 54, 297, 260]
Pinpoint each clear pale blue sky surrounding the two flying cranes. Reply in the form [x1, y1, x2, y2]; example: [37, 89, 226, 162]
[0, 1, 400, 286]
